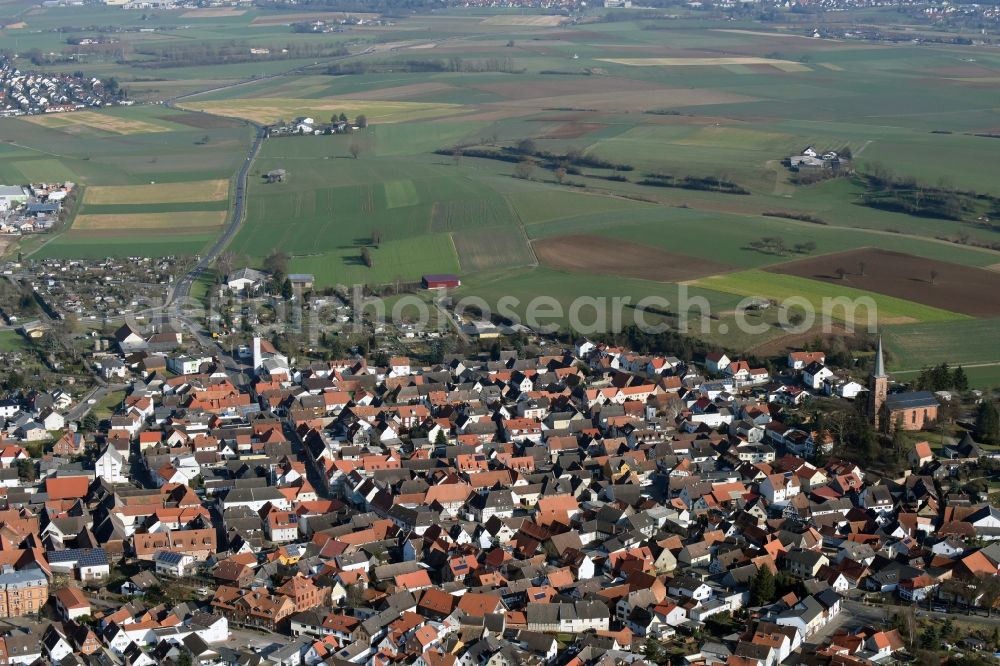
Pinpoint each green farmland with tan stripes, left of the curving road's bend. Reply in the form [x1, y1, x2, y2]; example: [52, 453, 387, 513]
[0, 107, 252, 258]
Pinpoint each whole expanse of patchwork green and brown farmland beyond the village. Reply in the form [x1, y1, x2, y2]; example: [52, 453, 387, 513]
[7, 0, 1000, 368]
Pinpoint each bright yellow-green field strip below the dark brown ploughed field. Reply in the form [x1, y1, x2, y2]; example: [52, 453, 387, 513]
[694, 270, 968, 325]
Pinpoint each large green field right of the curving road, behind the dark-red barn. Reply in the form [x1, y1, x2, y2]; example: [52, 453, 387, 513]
[232, 136, 517, 260]
